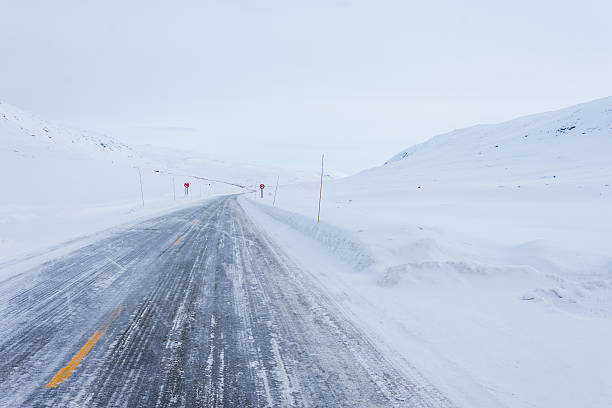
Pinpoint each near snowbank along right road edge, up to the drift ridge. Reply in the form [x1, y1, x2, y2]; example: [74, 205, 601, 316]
[241, 192, 612, 408]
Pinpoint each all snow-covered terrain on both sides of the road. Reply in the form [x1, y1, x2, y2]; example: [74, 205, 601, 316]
[0, 98, 612, 407]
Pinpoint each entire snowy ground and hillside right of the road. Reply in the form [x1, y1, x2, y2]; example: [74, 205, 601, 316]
[242, 98, 612, 407]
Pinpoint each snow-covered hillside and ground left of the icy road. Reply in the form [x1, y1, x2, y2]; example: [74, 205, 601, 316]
[0, 103, 316, 262]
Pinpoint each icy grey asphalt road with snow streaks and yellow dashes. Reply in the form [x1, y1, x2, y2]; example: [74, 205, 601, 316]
[0, 196, 449, 408]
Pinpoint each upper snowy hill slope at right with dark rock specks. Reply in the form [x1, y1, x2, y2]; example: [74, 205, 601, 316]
[385, 97, 612, 180]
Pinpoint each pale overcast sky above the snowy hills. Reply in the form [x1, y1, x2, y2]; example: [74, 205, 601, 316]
[0, 0, 612, 173]
